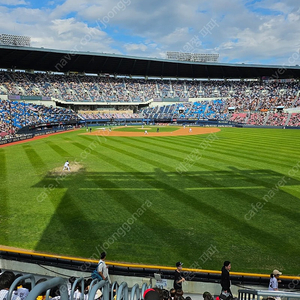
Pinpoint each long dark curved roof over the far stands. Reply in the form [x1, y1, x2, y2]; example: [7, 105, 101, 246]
[0, 45, 300, 79]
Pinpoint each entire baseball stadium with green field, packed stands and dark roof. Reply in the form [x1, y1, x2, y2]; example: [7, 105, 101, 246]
[0, 36, 300, 300]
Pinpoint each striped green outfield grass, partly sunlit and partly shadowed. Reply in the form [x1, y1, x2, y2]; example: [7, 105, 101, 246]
[0, 128, 300, 275]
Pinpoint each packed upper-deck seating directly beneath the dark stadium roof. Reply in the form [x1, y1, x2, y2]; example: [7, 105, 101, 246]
[0, 71, 300, 105]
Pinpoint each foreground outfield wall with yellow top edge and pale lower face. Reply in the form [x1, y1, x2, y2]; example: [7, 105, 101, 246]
[0, 246, 300, 295]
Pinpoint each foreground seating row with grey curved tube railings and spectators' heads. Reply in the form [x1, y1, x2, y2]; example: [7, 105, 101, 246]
[0, 270, 191, 300]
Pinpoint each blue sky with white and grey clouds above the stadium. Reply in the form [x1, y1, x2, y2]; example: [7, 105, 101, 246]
[0, 0, 300, 65]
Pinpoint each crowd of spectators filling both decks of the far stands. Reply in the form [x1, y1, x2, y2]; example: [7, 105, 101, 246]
[0, 71, 300, 127]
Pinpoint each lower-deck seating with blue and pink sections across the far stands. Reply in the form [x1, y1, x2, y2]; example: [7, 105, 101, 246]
[0, 99, 300, 138]
